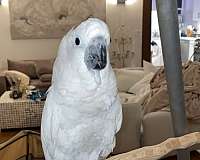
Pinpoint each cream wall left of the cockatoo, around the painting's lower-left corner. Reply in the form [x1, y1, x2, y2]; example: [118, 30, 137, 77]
[0, 1, 60, 70]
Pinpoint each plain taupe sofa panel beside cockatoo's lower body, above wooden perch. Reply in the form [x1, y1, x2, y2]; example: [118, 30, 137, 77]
[113, 103, 141, 155]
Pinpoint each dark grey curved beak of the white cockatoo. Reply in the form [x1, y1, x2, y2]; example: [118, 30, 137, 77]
[84, 37, 107, 70]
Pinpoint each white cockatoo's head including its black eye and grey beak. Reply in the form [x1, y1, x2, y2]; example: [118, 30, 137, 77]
[67, 18, 110, 70]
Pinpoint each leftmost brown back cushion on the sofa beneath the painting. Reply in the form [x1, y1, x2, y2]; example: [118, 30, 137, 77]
[7, 59, 38, 79]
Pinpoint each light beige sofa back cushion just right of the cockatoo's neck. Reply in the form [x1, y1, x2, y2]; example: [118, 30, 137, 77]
[114, 68, 144, 92]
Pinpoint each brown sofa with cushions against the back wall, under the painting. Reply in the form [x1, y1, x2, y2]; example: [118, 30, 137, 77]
[0, 59, 54, 96]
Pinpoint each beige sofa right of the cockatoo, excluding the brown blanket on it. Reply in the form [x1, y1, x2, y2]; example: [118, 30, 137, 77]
[114, 62, 200, 156]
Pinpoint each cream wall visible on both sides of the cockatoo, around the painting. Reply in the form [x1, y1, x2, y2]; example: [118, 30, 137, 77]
[0, 0, 143, 70]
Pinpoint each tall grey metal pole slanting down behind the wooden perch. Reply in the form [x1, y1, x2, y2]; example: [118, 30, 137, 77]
[156, 0, 190, 160]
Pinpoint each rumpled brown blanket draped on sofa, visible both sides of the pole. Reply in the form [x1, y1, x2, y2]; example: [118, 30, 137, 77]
[143, 61, 200, 120]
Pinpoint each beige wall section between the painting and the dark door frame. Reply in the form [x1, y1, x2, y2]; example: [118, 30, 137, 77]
[106, 0, 143, 67]
